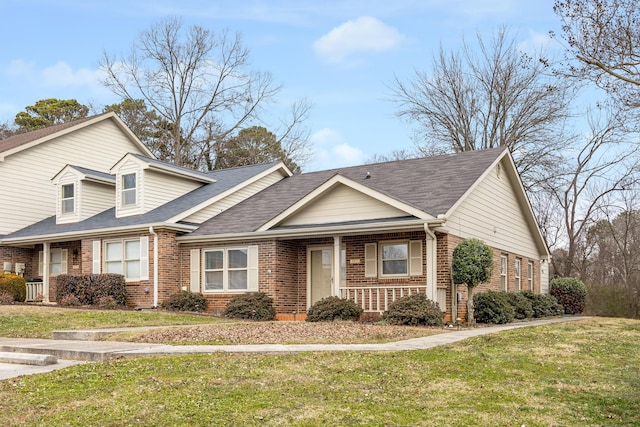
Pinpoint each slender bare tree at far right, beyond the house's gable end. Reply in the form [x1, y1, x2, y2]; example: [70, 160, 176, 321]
[546, 107, 640, 277]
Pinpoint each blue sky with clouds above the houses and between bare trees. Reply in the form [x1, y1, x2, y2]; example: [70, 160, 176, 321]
[0, 0, 560, 171]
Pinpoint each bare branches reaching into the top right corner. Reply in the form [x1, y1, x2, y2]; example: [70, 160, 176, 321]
[552, 0, 640, 107]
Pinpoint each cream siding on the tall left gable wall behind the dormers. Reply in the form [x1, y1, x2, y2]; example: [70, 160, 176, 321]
[0, 119, 142, 235]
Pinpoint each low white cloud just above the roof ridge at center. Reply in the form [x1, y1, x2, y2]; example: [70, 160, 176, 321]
[305, 128, 365, 171]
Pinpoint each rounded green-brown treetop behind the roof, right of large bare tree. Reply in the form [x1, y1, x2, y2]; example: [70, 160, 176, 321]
[214, 126, 300, 172]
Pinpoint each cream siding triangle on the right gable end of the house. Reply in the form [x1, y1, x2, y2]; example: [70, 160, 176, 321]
[447, 160, 541, 259]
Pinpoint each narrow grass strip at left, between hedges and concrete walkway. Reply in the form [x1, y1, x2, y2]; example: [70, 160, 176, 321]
[0, 305, 225, 338]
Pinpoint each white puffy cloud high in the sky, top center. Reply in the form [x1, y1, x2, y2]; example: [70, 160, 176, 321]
[313, 16, 404, 63]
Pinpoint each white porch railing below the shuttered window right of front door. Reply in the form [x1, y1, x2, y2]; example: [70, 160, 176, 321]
[340, 285, 427, 313]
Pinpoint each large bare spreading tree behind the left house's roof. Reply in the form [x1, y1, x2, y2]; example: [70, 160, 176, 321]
[101, 18, 309, 168]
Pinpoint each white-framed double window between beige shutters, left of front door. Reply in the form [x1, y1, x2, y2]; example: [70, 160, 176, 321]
[204, 248, 249, 292]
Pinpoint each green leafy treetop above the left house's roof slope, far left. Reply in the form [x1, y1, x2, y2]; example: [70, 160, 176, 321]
[15, 98, 89, 132]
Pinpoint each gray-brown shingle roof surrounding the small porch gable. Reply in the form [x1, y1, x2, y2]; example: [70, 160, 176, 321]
[190, 148, 506, 236]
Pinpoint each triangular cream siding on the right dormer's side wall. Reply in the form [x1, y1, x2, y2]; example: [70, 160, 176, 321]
[140, 170, 201, 213]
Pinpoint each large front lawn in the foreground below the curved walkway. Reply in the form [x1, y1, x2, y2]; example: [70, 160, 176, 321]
[0, 318, 640, 427]
